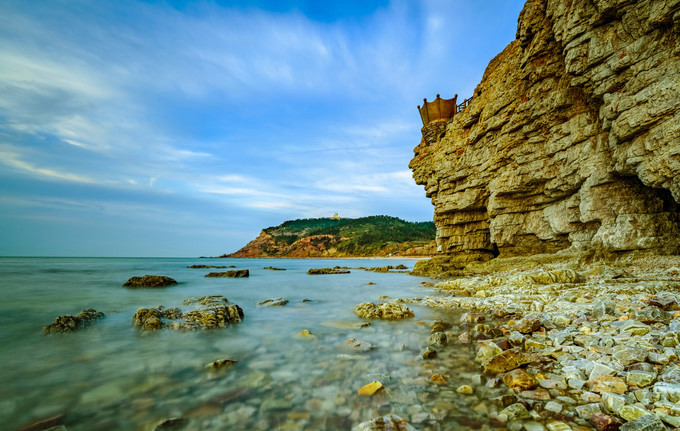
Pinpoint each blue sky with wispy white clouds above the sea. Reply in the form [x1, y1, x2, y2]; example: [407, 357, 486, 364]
[0, 0, 523, 257]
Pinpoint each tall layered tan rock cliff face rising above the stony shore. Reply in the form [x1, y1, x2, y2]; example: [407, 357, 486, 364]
[410, 0, 680, 261]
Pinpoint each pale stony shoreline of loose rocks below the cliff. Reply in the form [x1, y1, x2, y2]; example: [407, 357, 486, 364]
[399, 256, 680, 430]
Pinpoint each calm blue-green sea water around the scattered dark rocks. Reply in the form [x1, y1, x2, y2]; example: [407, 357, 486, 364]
[0, 257, 484, 431]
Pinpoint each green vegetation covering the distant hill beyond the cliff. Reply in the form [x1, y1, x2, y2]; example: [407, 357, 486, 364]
[265, 216, 435, 255]
